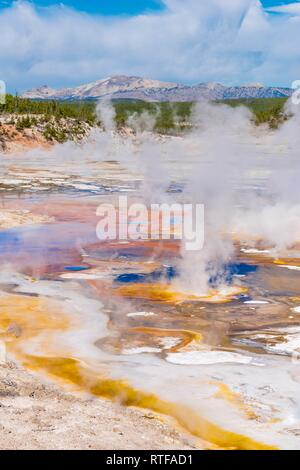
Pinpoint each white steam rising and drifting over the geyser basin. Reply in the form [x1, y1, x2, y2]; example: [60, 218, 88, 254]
[3, 101, 300, 293]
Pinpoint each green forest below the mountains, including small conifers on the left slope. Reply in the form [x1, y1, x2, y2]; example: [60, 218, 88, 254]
[0, 95, 288, 136]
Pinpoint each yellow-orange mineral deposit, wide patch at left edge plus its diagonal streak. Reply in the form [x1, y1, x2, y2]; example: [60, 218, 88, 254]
[0, 294, 274, 450]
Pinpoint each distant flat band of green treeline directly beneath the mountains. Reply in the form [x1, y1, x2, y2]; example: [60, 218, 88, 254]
[0, 95, 287, 133]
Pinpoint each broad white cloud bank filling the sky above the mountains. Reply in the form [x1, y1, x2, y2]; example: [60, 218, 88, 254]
[0, 0, 300, 91]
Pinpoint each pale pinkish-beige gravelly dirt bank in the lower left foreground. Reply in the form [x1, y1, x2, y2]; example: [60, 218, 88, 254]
[0, 362, 201, 450]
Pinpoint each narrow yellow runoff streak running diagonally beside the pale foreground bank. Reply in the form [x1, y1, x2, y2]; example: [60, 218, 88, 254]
[26, 356, 276, 450]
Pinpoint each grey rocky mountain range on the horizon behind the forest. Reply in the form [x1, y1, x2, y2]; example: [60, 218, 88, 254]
[22, 75, 293, 102]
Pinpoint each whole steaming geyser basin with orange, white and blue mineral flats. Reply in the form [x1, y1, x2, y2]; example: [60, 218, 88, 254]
[0, 98, 300, 448]
